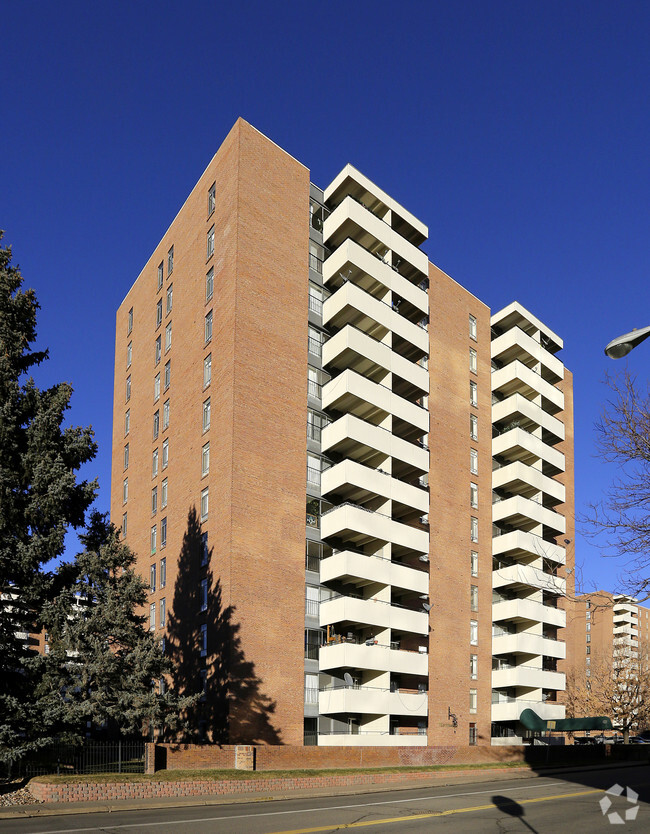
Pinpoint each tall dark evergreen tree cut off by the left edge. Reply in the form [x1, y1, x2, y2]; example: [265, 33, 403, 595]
[0, 232, 96, 761]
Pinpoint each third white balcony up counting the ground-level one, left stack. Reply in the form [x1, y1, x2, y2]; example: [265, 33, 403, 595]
[318, 643, 429, 676]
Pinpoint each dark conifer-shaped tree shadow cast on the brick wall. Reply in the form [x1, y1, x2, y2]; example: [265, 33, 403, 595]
[167, 507, 282, 744]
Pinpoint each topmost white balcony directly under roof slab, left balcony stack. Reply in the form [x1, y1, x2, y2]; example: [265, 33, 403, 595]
[323, 197, 429, 277]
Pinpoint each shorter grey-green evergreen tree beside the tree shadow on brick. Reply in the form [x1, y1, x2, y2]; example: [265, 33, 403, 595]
[36, 513, 198, 741]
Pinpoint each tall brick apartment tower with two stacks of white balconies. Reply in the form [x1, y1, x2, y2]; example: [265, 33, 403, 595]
[111, 119, 573, 746]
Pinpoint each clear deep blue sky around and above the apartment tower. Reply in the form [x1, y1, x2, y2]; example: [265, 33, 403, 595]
[0, 0, 650, 587]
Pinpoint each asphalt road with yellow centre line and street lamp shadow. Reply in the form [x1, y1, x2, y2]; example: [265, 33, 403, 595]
[0, 766, 650, 834]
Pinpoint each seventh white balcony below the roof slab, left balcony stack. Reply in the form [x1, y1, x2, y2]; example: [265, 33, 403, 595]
[321, 460, 429, 515]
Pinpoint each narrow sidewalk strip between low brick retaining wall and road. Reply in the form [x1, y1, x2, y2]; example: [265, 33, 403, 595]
[0, 762, 645, 820]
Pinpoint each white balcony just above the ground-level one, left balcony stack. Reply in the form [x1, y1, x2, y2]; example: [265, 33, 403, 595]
[318, 686, 429, 718]
